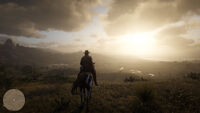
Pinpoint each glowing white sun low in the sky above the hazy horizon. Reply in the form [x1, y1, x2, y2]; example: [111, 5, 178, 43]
[120, 33, 156, 57]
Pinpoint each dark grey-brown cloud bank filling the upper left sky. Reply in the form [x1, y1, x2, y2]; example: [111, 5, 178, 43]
[0, 0, 99, 38]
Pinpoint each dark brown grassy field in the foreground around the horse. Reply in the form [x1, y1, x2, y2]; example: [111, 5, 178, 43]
[0, 69, 200, 113]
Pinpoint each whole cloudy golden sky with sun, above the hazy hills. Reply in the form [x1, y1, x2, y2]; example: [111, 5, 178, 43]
[0, 0, 200, 60]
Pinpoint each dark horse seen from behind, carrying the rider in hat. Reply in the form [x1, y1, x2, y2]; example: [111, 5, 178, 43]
[71, 72, 93, 112]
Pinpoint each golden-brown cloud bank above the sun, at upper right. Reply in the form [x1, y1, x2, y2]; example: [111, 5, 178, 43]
[104, 0, 200, 35]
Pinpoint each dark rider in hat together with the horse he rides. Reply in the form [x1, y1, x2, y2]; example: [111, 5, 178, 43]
[71, 50, 98, 111]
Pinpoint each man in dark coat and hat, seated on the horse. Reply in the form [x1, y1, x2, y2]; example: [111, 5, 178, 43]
[78, 50, 98, 86]
